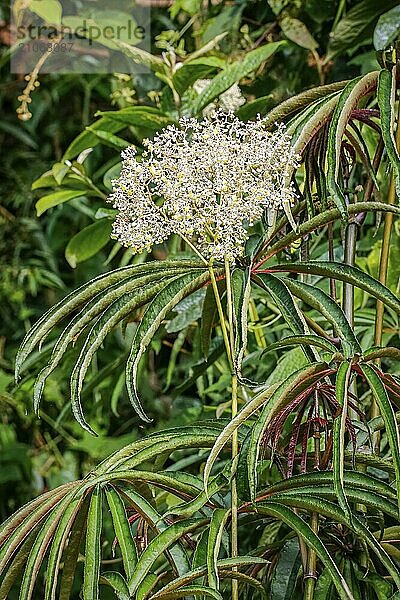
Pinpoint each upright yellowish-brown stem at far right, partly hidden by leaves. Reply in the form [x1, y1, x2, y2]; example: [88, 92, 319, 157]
[371, 96, 400, 438]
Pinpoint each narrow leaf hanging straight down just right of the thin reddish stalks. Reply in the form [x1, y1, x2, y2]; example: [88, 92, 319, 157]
[333, 362, 352, 523]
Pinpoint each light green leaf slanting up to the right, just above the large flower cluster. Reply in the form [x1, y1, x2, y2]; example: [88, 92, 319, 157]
[194, 41, 286, 114]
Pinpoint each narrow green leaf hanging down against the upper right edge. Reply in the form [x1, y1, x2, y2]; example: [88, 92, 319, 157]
[377, 67, 400, 197]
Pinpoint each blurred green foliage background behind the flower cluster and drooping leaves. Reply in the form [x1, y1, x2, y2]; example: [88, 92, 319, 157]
[0, 0, 400, 600]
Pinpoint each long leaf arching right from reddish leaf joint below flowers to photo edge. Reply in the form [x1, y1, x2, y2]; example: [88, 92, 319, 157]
[268, 260, 400, 314]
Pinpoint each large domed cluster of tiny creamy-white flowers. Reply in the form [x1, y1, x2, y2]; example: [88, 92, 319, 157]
[110, 111, 298, 261]
